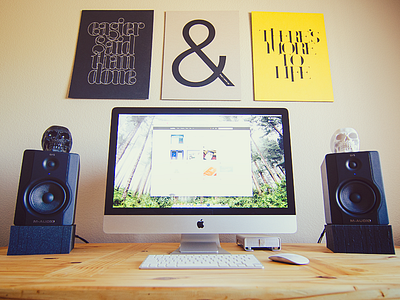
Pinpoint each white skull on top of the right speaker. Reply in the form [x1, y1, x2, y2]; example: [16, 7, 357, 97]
[331, 128, 360, 153]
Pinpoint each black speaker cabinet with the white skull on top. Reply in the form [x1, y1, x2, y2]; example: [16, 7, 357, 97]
[321, 151, 389, 225]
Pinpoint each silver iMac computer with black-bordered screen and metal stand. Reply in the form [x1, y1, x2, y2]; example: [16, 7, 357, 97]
[103, 107, 297, 253]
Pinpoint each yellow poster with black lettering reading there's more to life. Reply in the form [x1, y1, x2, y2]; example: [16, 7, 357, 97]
[251, 12, 333, 101]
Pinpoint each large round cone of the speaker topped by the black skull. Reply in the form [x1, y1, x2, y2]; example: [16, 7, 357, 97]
[27, 180, 67, 215]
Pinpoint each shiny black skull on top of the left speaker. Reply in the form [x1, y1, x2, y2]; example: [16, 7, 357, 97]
[42, 125, 72, 153]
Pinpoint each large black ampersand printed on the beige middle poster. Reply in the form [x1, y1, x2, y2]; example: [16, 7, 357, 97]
[172, 20, 234, 87]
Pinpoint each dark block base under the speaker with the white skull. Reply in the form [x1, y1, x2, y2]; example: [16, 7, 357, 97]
[325, 224, 395, 254]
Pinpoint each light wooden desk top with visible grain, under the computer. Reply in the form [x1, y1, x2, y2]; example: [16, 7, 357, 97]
[0, 243, 400, 300]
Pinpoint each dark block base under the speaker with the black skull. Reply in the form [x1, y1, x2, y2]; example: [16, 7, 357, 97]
[7, 225, 75, 255]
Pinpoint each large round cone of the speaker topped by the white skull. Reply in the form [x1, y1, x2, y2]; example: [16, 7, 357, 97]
[338, 180, 377, 214]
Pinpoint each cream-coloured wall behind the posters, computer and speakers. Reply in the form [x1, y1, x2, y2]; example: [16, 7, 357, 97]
[0, 0, 400, 246]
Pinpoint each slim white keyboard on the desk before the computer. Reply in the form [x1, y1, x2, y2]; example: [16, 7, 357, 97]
[139, 254, 264, 269]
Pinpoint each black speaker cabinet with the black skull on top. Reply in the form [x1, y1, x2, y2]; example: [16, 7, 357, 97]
[14, 150, 79, 226]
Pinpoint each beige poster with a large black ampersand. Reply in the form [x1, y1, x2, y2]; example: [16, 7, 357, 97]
[161, 11, 241, 100]
